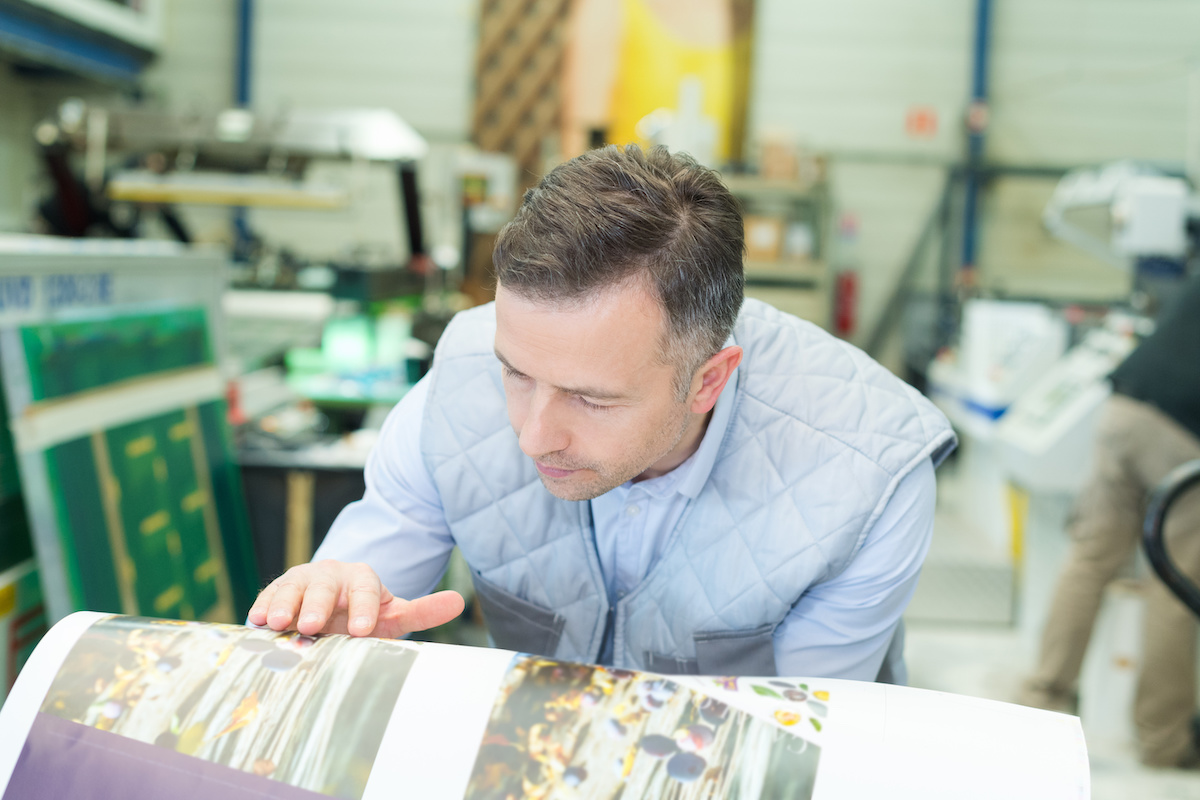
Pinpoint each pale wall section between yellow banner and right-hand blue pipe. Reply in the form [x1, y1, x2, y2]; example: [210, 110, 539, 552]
[750, 0, 973, 156]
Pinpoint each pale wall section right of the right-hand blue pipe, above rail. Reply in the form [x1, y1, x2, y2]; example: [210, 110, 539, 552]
[984, 0, 1200, 164]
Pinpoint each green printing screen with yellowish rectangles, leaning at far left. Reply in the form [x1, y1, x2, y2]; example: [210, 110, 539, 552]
[12, 309, 257, 621]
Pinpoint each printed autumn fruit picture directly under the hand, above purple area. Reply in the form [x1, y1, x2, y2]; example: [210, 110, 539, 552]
[41, 618, 416, 800]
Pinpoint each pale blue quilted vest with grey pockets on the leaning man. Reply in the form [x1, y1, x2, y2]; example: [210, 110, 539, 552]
[421, 300, 955, 675]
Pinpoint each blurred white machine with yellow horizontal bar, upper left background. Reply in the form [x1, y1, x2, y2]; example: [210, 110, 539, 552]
[34, 100, 430, 273]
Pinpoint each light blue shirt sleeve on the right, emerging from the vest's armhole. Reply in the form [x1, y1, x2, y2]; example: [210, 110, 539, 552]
[775, 459, 937, 681]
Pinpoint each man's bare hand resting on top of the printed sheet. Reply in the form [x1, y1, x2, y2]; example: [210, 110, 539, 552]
[250, 560, 463, 638]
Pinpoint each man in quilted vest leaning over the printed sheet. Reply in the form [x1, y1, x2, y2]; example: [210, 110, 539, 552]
[251, 146, 954, 680]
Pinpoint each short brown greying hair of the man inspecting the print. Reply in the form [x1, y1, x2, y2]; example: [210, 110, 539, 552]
[492, 145, 744, 397]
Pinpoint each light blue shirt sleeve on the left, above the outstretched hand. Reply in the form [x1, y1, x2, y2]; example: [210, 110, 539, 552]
[313, 378, 454, 599]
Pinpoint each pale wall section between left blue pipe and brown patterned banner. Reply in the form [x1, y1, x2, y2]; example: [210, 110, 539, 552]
[252, 0, 478, 139]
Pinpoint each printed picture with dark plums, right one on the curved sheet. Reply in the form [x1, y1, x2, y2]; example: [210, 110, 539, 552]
[466, 656, 821, 800]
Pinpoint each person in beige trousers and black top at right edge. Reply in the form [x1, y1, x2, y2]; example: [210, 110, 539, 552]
[1020, 277, 1200, 769]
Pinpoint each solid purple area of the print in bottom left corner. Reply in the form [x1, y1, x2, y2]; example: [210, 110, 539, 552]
[4, 714, 325, 800]
